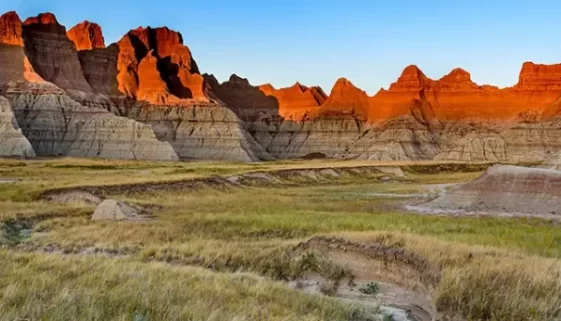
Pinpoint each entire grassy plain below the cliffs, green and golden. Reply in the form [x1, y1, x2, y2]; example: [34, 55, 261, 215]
[0, 159, 561, 320]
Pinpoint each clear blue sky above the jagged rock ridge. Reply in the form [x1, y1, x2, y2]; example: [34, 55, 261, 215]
[0, 0, 561, 94]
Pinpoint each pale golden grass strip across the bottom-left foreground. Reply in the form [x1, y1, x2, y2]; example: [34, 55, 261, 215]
[0, 251, 376, 321]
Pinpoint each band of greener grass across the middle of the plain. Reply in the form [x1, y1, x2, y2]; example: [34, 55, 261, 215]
[37, 184, 561, 257]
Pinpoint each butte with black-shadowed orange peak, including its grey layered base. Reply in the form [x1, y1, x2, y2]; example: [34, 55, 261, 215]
[60, 21, 270, 161]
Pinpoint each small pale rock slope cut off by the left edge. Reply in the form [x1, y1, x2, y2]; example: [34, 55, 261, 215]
[0, 96, 35, 157]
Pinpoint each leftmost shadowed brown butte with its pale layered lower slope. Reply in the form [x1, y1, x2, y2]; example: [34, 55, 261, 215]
[0, 14, 178, 160]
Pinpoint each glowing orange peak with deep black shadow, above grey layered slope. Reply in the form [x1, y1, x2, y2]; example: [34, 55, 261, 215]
[117, 27, 209, 105]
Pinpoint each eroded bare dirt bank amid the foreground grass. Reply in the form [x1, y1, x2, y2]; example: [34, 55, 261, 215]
[294, 236, 440, 321]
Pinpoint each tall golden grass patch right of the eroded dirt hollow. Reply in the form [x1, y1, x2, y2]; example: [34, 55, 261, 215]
[336, 232, 561, 320]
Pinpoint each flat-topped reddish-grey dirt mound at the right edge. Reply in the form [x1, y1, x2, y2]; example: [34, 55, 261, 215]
[422, 165, 561, 215]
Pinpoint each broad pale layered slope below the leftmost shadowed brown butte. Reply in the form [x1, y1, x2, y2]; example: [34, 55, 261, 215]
[4, 84, 178, 161]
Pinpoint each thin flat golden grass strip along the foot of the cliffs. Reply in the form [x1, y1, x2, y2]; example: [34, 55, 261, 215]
[0, 158, 492, 201]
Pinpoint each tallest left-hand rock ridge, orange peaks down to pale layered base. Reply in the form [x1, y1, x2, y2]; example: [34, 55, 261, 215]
[0, 13, 271, 161]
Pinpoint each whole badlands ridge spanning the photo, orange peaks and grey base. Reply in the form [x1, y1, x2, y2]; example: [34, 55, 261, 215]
[0, 12, 561, 162]
